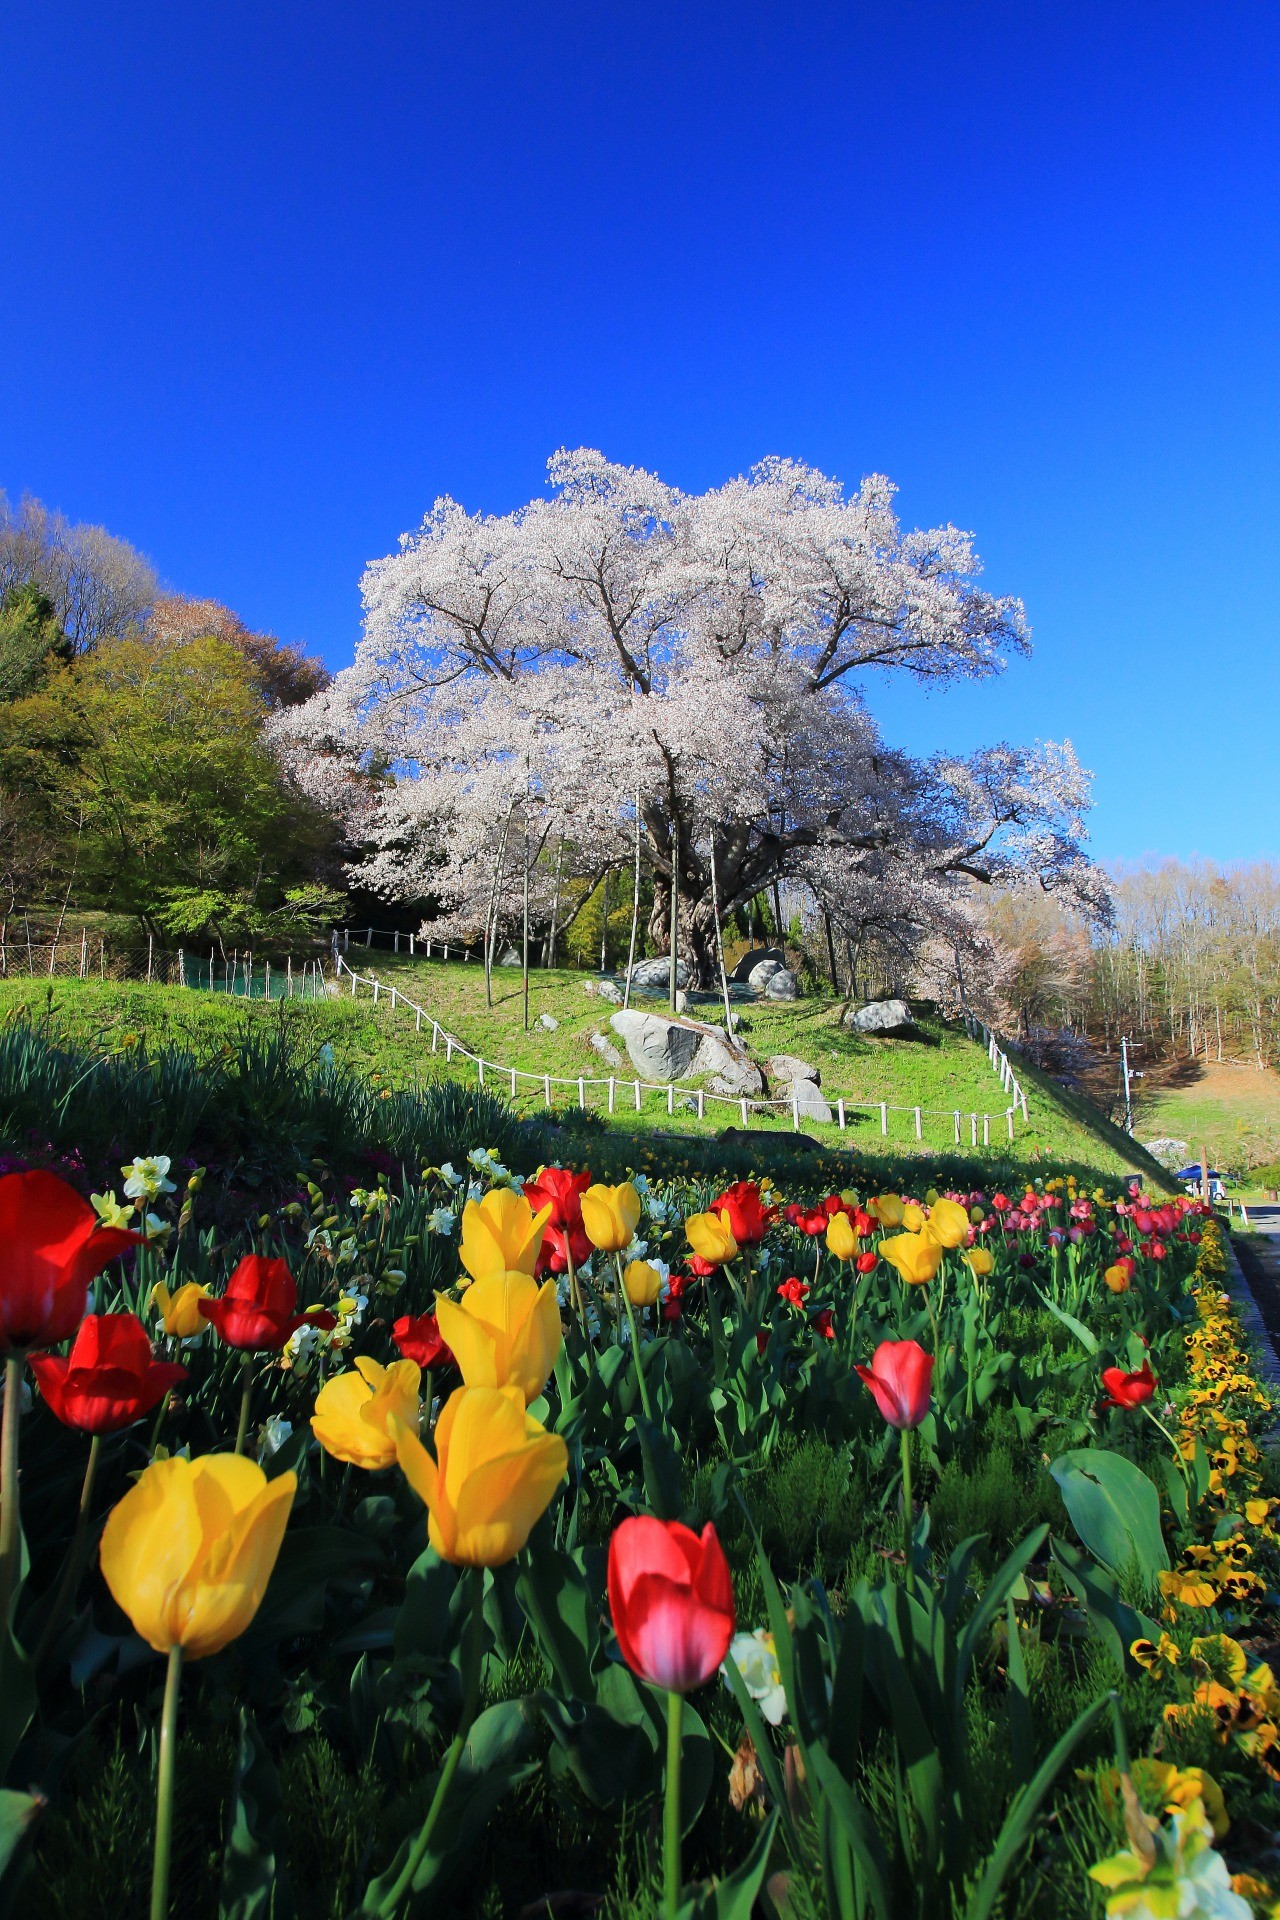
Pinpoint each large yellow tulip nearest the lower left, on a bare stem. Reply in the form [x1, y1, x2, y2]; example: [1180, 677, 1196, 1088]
[102, 1453, 297, 1661]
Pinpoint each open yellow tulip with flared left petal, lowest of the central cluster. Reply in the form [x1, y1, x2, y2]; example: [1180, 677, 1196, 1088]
[390, 1386, 568, 1567]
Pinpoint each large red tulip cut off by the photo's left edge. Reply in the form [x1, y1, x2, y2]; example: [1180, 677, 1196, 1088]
[0, 1173, 142, 1352]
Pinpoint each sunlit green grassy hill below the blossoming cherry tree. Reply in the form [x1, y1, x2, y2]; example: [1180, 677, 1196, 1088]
[0, 952, 1155, 1177]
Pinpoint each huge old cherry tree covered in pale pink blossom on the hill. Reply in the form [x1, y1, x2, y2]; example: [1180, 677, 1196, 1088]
[274, 449, 1098, 985]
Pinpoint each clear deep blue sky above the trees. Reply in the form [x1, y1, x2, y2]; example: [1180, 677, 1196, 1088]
[0, 0, 1280, 858]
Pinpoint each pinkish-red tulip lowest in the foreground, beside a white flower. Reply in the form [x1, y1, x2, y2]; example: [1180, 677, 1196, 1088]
[608, 1515, 735, 1693]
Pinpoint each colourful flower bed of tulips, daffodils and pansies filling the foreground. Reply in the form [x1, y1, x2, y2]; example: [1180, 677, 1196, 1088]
[0, 1150, 1280, 1920]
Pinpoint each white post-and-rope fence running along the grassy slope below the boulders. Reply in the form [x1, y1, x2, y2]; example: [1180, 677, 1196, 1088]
[334, 952, 1027, 1146]
